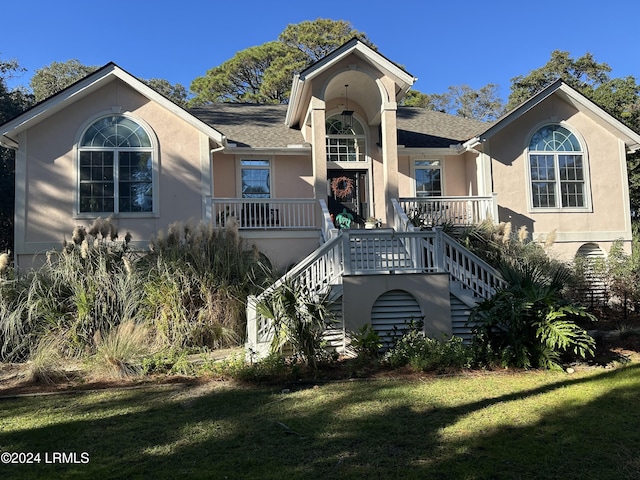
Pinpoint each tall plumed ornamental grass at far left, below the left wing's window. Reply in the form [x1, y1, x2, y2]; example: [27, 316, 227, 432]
[0, 218, 141, 361]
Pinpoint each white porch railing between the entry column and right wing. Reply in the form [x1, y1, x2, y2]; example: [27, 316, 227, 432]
[398, 194, 498, 227]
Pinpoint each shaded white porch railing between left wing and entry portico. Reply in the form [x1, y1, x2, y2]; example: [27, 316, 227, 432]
[207, 197, 323, 230]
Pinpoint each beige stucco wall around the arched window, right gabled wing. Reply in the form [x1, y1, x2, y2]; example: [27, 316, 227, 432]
[483, 96, 631, 258]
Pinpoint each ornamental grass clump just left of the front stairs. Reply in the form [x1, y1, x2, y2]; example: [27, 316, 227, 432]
[142, 222, 271, 348]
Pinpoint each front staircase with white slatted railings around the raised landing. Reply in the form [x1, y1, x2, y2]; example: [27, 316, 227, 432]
[246, 223, 504, 358]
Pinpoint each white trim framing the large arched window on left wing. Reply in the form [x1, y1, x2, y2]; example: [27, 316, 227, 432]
[73, 108, 160, 219]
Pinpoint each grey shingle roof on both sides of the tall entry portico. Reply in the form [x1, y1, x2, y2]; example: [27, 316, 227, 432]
[189, 103, 489, 148]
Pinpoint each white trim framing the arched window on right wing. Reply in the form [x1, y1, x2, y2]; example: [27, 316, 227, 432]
[524, 122, 593, 213]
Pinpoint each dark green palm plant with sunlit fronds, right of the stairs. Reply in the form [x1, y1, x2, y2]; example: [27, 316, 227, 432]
[469, 262, 595, 368]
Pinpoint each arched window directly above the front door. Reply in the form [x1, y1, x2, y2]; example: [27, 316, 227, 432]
[325, 114, 366, 162]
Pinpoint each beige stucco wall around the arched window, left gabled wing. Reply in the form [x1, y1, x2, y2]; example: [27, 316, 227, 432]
[16, 81, 208, 265]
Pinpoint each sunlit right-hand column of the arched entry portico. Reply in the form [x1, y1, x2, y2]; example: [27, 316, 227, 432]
[376, 102, 400, 224]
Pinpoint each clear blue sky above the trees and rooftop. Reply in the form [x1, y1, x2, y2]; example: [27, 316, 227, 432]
[0, 0, 640, 98]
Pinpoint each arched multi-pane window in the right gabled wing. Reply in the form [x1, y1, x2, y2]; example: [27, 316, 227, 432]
[529, 125, 587, 208]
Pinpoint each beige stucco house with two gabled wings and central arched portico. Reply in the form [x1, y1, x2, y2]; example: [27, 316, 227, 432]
[0, 39, 640, 354]
